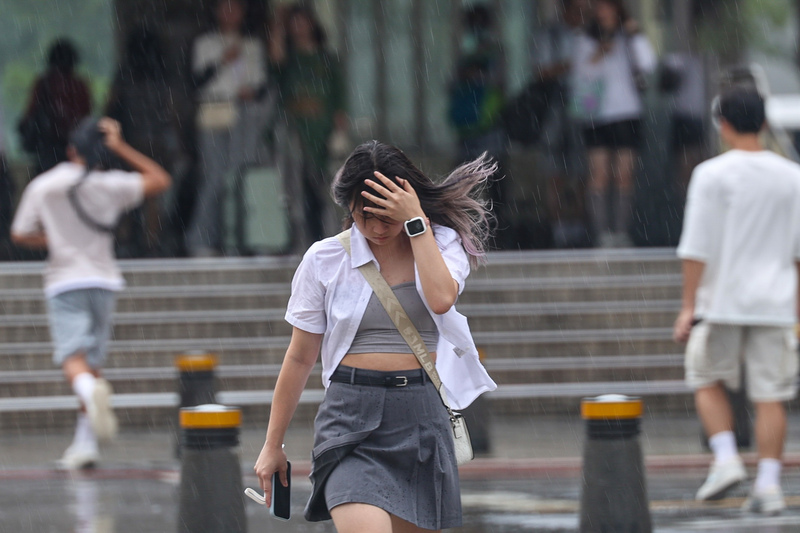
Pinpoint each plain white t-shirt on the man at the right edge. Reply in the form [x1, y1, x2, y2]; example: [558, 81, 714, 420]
[678, 150, 800, 326]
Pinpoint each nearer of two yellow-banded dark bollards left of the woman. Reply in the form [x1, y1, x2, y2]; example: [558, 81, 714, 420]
[178, 404, 247, 533]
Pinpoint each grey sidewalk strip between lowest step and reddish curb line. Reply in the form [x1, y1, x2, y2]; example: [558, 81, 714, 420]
[0, 413, 800, 476]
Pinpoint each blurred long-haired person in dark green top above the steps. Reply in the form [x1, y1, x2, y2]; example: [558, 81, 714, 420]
[269, 5, 348, 242]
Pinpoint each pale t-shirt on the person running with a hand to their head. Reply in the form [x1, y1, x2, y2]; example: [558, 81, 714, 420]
[11, 163, 144, 297]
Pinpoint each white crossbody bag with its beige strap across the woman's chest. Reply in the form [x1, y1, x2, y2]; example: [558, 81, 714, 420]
[336, 230, 475, 465]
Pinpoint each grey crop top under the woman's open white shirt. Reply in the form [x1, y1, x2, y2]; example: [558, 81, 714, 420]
[347, 281, 439, 353]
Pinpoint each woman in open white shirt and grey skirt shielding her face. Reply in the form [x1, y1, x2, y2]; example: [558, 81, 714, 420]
[255, 141, 496, 533]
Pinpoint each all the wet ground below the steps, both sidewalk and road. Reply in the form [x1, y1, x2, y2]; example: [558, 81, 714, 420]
[0, 416, 800, 533]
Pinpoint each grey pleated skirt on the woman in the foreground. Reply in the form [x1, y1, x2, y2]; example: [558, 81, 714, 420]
[305, 366, 461, 529]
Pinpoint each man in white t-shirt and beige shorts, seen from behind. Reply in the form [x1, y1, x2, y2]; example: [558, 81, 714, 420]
[674, 88, 800, 514]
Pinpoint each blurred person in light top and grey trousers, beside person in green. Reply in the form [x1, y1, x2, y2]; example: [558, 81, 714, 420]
[186, 0, 267, 257]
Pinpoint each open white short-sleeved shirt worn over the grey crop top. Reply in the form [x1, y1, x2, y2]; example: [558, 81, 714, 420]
[286, 225, 497, 409]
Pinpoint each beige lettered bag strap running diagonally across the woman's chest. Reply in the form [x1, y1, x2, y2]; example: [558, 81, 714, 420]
[336, 230, 451, 412]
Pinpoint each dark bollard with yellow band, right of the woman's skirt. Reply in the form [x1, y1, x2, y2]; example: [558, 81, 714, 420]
[580, 394, 653, 533]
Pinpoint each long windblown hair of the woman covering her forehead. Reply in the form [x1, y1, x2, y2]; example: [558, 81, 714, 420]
[331, 141, 497, 267]
